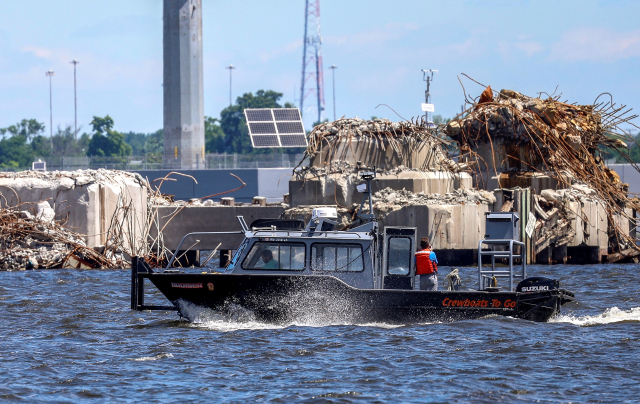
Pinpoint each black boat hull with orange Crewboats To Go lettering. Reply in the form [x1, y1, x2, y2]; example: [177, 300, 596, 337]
[142, 273, 574, 324]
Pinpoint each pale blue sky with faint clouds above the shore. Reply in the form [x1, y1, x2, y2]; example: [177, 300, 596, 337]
[0, 0, 640, 132]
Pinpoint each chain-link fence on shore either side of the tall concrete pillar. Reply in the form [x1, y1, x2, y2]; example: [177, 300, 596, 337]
[0, 153, 303, 171]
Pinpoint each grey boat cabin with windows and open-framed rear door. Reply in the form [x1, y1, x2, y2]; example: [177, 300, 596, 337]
[225, 208, 416, 289]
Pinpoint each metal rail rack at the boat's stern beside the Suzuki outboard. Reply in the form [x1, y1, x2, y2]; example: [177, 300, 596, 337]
[478, 239, 527, 291]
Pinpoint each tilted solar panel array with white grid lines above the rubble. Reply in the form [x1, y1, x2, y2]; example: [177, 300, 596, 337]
[244, 108, 307, 147]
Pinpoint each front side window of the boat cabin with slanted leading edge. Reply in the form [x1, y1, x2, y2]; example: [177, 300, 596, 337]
[242, 241, 305, 271]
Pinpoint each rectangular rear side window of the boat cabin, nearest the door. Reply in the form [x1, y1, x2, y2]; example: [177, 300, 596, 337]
[311, 243, 364, 272]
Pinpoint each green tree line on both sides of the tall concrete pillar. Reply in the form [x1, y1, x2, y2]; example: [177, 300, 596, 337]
[0, 90, 303, 169]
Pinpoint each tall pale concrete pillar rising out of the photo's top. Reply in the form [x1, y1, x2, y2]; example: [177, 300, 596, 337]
[163, 0, 204, 169]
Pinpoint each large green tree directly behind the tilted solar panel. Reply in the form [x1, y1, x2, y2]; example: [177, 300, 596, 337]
[220, 90, 293, 154]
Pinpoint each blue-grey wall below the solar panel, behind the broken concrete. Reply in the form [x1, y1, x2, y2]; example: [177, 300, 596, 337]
[135, 168, 292, 202]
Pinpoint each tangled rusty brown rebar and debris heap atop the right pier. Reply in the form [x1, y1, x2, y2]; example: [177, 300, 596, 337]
[444, 87, 640, 251]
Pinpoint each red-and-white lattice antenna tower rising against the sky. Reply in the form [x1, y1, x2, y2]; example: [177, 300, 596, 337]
[300, 0, 324, 122]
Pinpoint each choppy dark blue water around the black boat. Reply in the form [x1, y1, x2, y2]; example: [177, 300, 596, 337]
[0, 265, 640, 403]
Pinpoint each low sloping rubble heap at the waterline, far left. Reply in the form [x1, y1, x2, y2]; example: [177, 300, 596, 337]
[0, 202, 123, 271]
